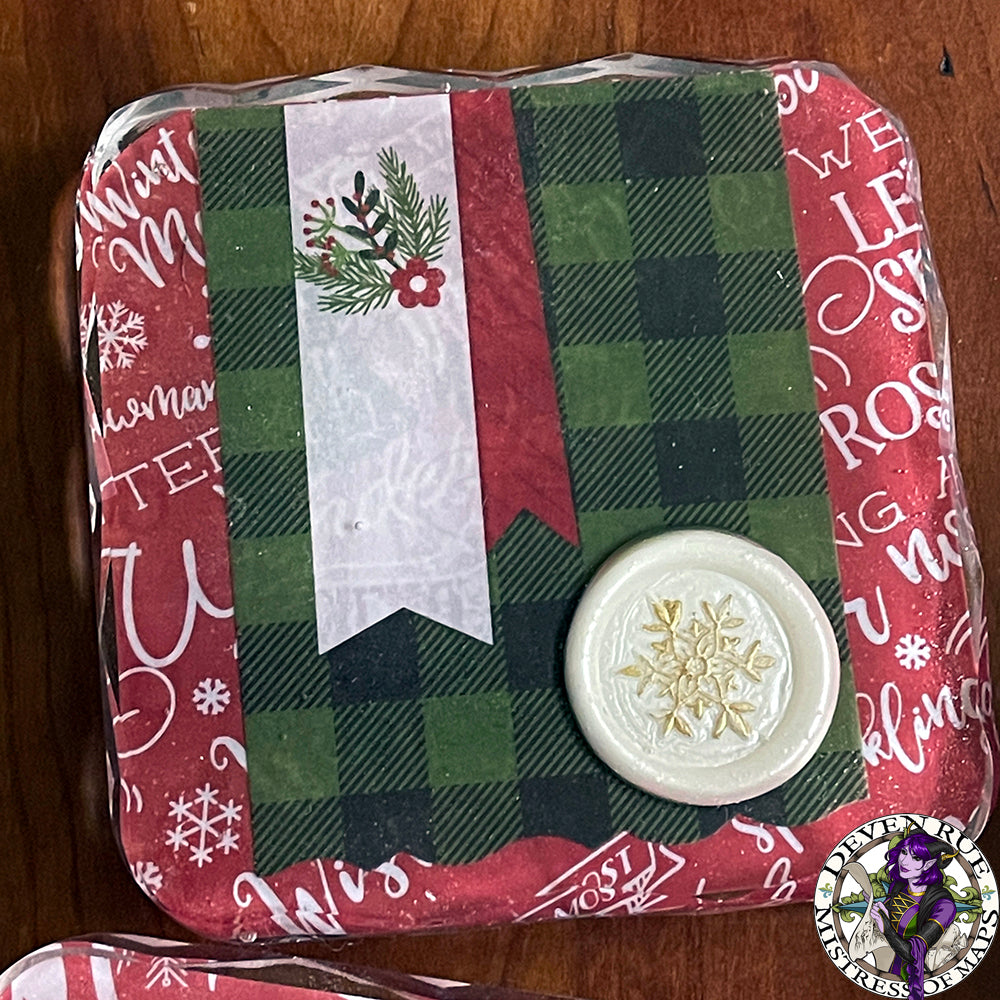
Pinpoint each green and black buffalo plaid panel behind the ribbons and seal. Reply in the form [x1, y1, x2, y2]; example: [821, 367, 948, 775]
[197, 72, 866, 873]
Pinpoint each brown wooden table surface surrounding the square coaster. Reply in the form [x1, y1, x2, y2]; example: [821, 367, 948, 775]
[0, 0, 1000, 1000]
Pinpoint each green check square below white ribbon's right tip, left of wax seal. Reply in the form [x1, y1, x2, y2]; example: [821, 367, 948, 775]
[424, 691, 517, 788]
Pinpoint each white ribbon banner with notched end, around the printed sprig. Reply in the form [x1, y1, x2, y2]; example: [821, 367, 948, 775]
[285, 95, 493, 652]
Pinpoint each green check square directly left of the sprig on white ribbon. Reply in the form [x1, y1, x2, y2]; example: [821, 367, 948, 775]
[204, 206, 294, 292]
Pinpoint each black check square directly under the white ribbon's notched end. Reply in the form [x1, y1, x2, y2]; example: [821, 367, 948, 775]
[325, 611, 421, 705]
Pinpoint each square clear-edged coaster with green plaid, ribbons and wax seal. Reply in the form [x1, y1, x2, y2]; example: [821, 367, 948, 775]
[78, 56, 996, 940]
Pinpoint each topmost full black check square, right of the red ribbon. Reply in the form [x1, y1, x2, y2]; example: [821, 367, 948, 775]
[615, 94, 705, 179]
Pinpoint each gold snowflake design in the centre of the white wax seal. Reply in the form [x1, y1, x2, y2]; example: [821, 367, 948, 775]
[618, 594, 775, 739]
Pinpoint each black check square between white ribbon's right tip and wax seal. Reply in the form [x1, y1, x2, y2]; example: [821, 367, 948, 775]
[500, 599, 576, 691]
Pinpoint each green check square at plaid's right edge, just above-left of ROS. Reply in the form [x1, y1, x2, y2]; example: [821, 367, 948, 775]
[729, 330, 816, 416]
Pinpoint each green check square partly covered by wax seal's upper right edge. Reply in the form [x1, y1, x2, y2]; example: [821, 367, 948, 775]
[747, 493, 838, 580]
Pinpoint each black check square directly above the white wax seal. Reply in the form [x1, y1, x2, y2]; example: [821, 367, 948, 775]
[654, 417, 746, 506]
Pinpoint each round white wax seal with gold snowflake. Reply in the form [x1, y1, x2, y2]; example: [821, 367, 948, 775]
[566, 530, 840, 806]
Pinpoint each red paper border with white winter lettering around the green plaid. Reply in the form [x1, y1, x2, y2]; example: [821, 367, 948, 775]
[79, 64, 997, 940]
